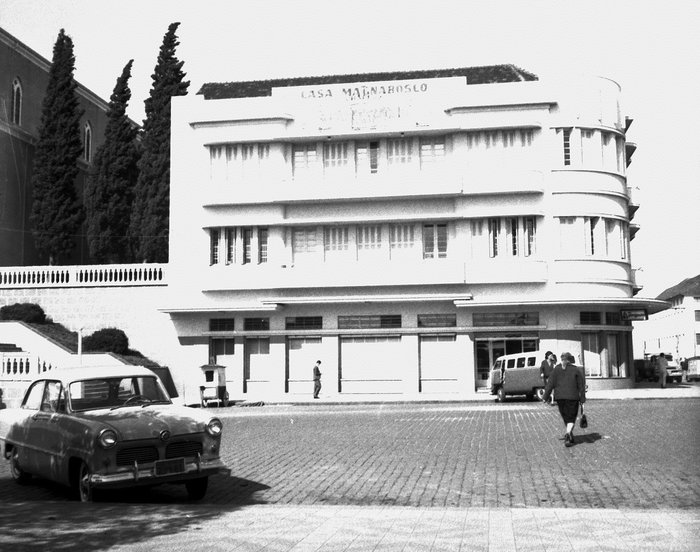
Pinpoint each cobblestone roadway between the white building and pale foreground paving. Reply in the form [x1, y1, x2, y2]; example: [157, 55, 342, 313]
[0, 399, 700, 508]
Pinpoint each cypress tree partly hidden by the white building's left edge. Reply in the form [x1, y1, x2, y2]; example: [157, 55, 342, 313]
[130, 23, 190, 262]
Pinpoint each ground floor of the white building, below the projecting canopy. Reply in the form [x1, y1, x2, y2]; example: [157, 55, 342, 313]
[168, 305, 632, 403]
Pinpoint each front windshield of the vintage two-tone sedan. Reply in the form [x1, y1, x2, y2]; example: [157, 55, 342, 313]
[68, 375, 170, 412]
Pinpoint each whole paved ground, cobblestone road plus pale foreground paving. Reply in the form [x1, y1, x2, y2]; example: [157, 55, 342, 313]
[0, 399, 700, 550]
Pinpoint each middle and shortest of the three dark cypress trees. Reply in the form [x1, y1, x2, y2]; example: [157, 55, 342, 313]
[85, 59, 139, 263]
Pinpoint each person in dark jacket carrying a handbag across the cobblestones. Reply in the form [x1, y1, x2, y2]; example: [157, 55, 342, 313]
[542, 353, 586, 447]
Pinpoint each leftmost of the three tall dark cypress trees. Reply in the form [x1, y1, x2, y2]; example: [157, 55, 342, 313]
[30, 29, 84, 264]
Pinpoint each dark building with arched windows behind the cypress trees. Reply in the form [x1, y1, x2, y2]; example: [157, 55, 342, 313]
[0, 28, 110, 266]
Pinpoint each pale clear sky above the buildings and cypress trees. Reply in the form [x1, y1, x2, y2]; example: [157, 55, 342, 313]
[0, 0, 700, 297]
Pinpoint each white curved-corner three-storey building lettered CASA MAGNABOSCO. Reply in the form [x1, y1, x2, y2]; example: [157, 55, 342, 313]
[162, 65, 665, 400]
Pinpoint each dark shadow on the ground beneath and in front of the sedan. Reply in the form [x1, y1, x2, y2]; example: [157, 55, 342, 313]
[0, 477, 268, 552]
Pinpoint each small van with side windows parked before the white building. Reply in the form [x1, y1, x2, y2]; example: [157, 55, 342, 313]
[491, 351, 544, 402]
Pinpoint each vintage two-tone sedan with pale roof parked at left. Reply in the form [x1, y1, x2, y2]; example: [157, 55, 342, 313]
[0, 366, 230, 502]
